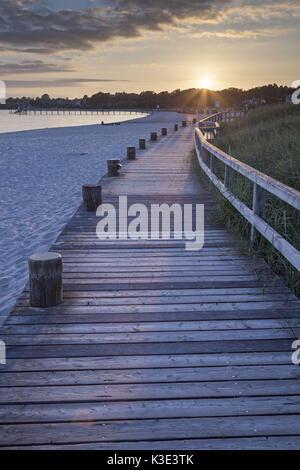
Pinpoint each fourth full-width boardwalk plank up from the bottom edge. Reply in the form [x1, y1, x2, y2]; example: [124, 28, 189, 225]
[0, 362, 300, 393]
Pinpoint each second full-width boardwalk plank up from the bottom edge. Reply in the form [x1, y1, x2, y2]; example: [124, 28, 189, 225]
[0, 395, 300, 424]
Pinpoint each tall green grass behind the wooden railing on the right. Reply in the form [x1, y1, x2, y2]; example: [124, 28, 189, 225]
[198, 104, 300, 297]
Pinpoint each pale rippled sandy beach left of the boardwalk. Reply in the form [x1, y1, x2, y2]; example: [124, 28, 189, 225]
[0, 112, 191, 325]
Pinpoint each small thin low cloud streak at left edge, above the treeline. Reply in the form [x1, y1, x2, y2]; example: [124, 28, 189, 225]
[0, 60, 75, 76]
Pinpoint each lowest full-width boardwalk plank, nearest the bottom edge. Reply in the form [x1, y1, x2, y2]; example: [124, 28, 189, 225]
[0, 415, 300, 447]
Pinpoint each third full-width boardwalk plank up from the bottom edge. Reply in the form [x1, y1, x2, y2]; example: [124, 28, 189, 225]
[0, 379, 300, 405]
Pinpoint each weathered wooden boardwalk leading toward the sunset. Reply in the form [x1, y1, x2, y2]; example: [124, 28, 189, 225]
[0, 120, 300, 449]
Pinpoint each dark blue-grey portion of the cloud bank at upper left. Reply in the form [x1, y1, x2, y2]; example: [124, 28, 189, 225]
[0, 0, 230, 53]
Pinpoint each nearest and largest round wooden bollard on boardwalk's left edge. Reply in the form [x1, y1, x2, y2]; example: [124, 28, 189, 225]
[28, 252, 63, 308]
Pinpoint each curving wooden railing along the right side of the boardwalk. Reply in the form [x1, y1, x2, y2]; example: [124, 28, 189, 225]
[195, 113, 300, 270]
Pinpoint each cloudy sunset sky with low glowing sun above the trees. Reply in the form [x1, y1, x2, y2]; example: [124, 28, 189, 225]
[0, 0, 300, 98]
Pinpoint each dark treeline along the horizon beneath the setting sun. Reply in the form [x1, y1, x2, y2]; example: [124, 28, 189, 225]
[2, 83, 294, 109]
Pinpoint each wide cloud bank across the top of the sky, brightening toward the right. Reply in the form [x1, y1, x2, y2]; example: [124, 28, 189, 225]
[0, 0, 300, 55]
